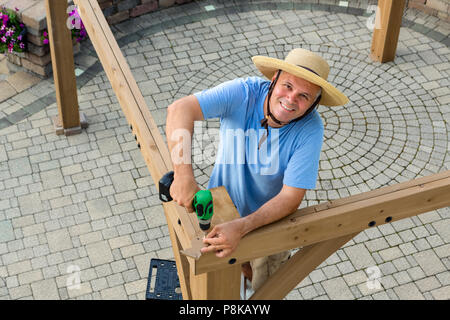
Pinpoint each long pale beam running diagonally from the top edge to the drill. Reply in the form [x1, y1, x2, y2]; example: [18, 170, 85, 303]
[75, 0, 197, 247]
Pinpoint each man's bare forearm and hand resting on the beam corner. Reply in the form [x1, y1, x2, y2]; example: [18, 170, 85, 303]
[201, 185, 306, 258]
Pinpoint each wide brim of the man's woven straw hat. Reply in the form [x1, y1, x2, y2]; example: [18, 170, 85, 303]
[252, 56, 349, 107]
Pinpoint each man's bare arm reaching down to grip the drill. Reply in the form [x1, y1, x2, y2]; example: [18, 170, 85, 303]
[166, 95, 204, 212]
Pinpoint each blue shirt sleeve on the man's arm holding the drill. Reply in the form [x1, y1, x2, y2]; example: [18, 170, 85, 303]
[194, 79, 248, 119]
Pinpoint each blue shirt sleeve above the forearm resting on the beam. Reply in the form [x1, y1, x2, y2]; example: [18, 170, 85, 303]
[283, 120, 323, 189]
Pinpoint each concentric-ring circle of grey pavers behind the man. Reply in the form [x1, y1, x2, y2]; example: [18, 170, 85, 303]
[133, 19, 447, 205]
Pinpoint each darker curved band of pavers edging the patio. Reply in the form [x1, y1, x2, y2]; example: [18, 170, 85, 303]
[0, 2, 450, 130]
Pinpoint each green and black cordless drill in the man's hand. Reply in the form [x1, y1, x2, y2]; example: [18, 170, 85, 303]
[159, 171, 213, 231]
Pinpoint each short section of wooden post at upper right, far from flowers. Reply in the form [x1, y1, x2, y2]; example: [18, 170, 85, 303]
[370, 0, 405, 63]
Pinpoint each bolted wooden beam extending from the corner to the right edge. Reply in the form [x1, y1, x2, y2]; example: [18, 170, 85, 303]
[195, 171, 450, 273]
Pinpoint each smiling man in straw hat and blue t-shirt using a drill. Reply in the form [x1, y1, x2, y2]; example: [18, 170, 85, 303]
[166, 49, 348, 290]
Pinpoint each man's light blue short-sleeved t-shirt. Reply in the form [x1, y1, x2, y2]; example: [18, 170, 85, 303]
[194, 77, 323, 216]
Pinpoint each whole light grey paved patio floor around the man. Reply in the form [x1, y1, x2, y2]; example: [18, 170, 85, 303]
[0, 0, 450, 300]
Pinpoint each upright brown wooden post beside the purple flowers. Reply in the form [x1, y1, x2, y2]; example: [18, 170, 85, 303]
[46, 0, 87, 136]
